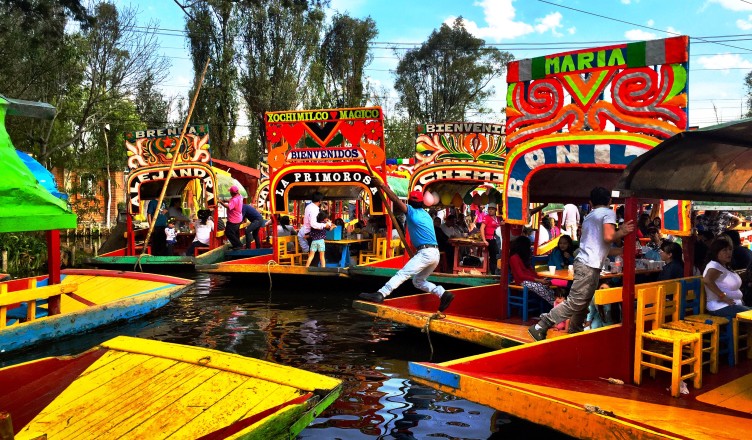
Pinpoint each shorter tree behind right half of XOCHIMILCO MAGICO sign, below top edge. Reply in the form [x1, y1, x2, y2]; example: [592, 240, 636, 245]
[314, 13, 378, 108]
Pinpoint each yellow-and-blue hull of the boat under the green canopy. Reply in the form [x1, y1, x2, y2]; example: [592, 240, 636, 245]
[0, 269, 193, 351]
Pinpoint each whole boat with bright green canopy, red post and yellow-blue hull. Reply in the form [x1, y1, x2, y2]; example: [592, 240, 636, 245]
[0, 96, 193, 351]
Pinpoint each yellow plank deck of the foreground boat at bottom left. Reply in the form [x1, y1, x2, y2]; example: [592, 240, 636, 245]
[16, 351, 310, 439]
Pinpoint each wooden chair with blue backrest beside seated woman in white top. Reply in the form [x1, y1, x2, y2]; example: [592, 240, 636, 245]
[679, 277, 736, 367]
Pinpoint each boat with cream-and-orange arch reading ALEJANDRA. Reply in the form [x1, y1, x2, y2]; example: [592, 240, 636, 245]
[88, 125, 251, 271]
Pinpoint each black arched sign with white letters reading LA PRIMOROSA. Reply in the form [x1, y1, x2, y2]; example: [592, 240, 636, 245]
[274, 171, 383, 214]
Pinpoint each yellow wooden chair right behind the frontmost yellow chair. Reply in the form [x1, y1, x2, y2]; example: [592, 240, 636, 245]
[661, 281, 719, 373]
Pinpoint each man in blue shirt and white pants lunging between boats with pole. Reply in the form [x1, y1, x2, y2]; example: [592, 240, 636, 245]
[359, 175, 454, 312]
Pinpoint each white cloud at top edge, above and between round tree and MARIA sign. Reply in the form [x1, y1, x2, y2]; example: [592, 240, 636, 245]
[444, 0, 564, 41]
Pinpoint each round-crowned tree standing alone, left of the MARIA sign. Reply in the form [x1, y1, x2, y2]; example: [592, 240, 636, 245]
[394, 17, 513, 123]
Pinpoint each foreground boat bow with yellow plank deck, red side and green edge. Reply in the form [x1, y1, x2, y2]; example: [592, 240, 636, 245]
[0, 336, 342, 439]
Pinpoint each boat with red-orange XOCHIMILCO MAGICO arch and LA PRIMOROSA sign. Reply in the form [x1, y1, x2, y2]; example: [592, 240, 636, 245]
[197, 107, 391, 278]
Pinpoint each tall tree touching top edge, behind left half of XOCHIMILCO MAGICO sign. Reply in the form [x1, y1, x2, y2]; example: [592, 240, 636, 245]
[239, 0, 324, 155]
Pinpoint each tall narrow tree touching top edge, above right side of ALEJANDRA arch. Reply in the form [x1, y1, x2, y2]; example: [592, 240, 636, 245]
[175, 0, 240, 159]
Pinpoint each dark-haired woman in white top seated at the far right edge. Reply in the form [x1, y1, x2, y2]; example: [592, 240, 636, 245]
[702, 238, 752, 320]
